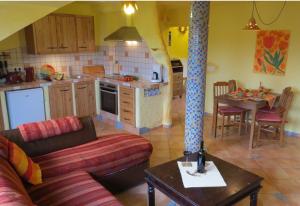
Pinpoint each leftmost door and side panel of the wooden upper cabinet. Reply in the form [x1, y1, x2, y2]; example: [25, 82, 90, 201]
[25, 15, 58, 54]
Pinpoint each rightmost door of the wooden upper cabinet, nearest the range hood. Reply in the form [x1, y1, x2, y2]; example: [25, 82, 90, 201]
[76, 16, 95, 52]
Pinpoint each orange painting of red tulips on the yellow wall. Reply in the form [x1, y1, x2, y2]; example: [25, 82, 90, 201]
[254, 30, 290, 75]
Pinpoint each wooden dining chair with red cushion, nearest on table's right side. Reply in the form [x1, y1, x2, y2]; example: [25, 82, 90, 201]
[256, 89, 294, 146]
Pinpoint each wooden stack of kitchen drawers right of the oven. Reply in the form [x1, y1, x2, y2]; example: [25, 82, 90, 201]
[120, 86, 135, 126]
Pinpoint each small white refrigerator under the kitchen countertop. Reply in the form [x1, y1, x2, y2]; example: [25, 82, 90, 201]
[5, 88, 46, 129]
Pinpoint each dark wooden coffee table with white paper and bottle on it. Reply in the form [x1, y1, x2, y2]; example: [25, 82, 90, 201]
[145, 154, 263, 206]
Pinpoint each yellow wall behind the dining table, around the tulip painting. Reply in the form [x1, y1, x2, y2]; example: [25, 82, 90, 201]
[206, 2, 300, 133]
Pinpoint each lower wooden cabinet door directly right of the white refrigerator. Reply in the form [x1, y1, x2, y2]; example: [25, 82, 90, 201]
[49, 83, 73, 119]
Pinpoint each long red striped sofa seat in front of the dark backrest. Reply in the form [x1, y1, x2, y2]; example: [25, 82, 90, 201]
[33, 134, 152, 178]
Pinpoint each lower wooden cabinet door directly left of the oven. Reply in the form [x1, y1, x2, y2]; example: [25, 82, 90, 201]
[75, 81, 96, 117]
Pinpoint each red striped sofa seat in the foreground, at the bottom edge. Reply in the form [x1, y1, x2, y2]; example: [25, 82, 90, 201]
[29, 171, 122, 206]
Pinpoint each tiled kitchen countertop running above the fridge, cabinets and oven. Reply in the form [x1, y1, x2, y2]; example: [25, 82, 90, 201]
[0, 76, 168, 91]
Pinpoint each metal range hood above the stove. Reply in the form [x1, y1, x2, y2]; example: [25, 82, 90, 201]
[104, 26, 142, 41]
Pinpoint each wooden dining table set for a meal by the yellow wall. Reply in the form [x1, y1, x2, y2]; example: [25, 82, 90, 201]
[212, 94, 268, 150]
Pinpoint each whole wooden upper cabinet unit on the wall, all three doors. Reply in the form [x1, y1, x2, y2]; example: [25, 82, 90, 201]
[25, 14, 95, 54]
